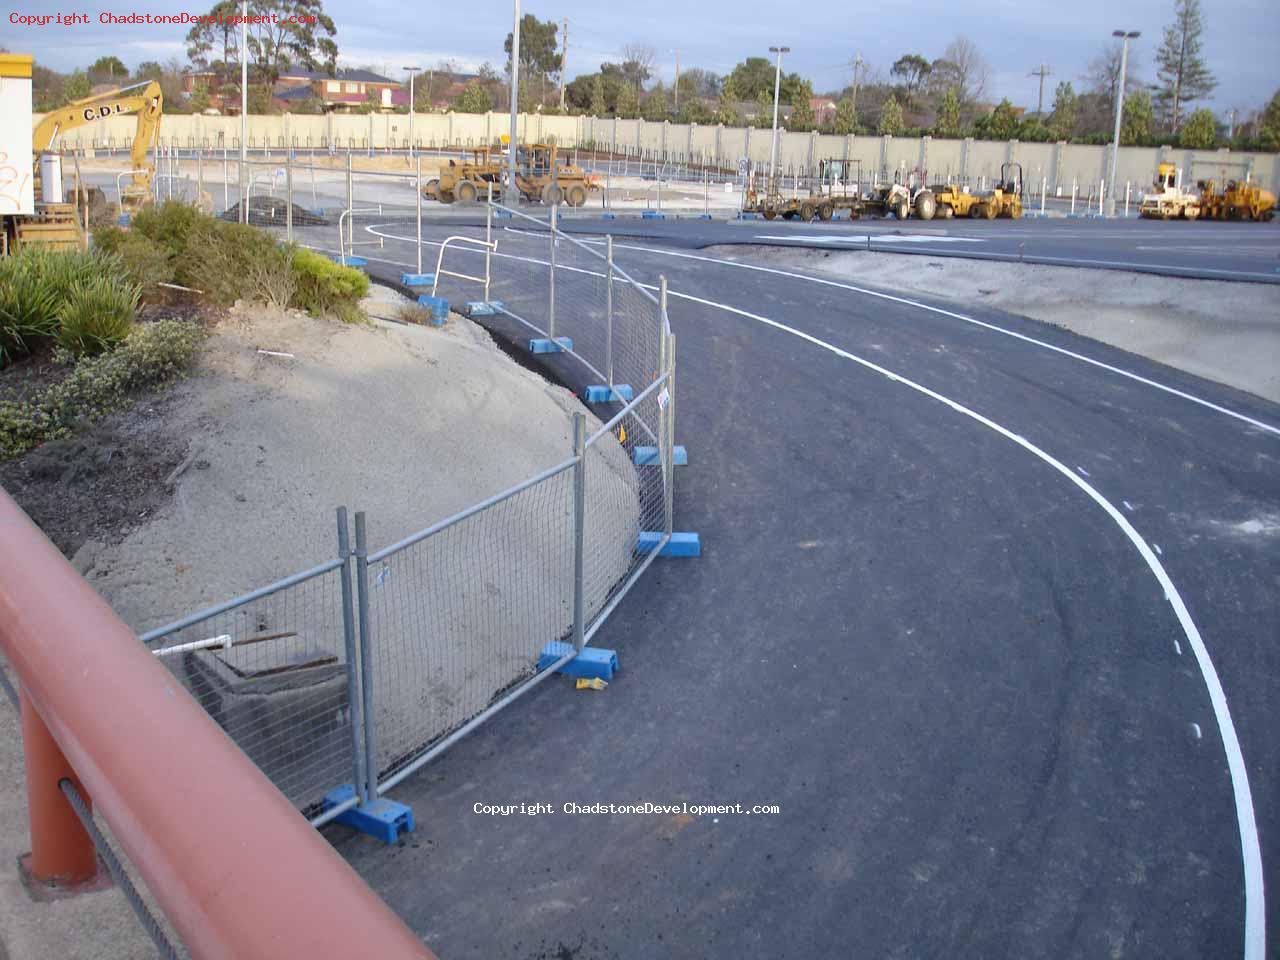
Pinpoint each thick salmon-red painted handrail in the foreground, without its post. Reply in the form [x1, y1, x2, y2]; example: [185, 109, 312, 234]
[0, 492, 434, 960]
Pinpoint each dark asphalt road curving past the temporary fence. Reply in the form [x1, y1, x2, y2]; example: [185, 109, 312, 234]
[314, 223, 1280, 960]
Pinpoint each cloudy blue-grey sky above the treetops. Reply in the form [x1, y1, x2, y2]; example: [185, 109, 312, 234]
[10, 0, 1280, 111]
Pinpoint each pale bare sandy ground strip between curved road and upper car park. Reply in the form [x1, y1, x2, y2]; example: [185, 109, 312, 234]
[719, 247, 1280, 402]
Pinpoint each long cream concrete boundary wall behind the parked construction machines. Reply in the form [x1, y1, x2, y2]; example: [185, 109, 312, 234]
[35, 113, 1280, 196]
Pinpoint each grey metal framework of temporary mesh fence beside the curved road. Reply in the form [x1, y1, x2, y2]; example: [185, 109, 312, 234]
[141, 199, 676, 827]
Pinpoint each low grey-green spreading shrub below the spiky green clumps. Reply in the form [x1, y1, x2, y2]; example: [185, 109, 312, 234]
[0, 320, 204, 458]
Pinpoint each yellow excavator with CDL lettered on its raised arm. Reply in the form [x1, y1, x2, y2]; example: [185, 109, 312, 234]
[4, 81, 164, 250]
